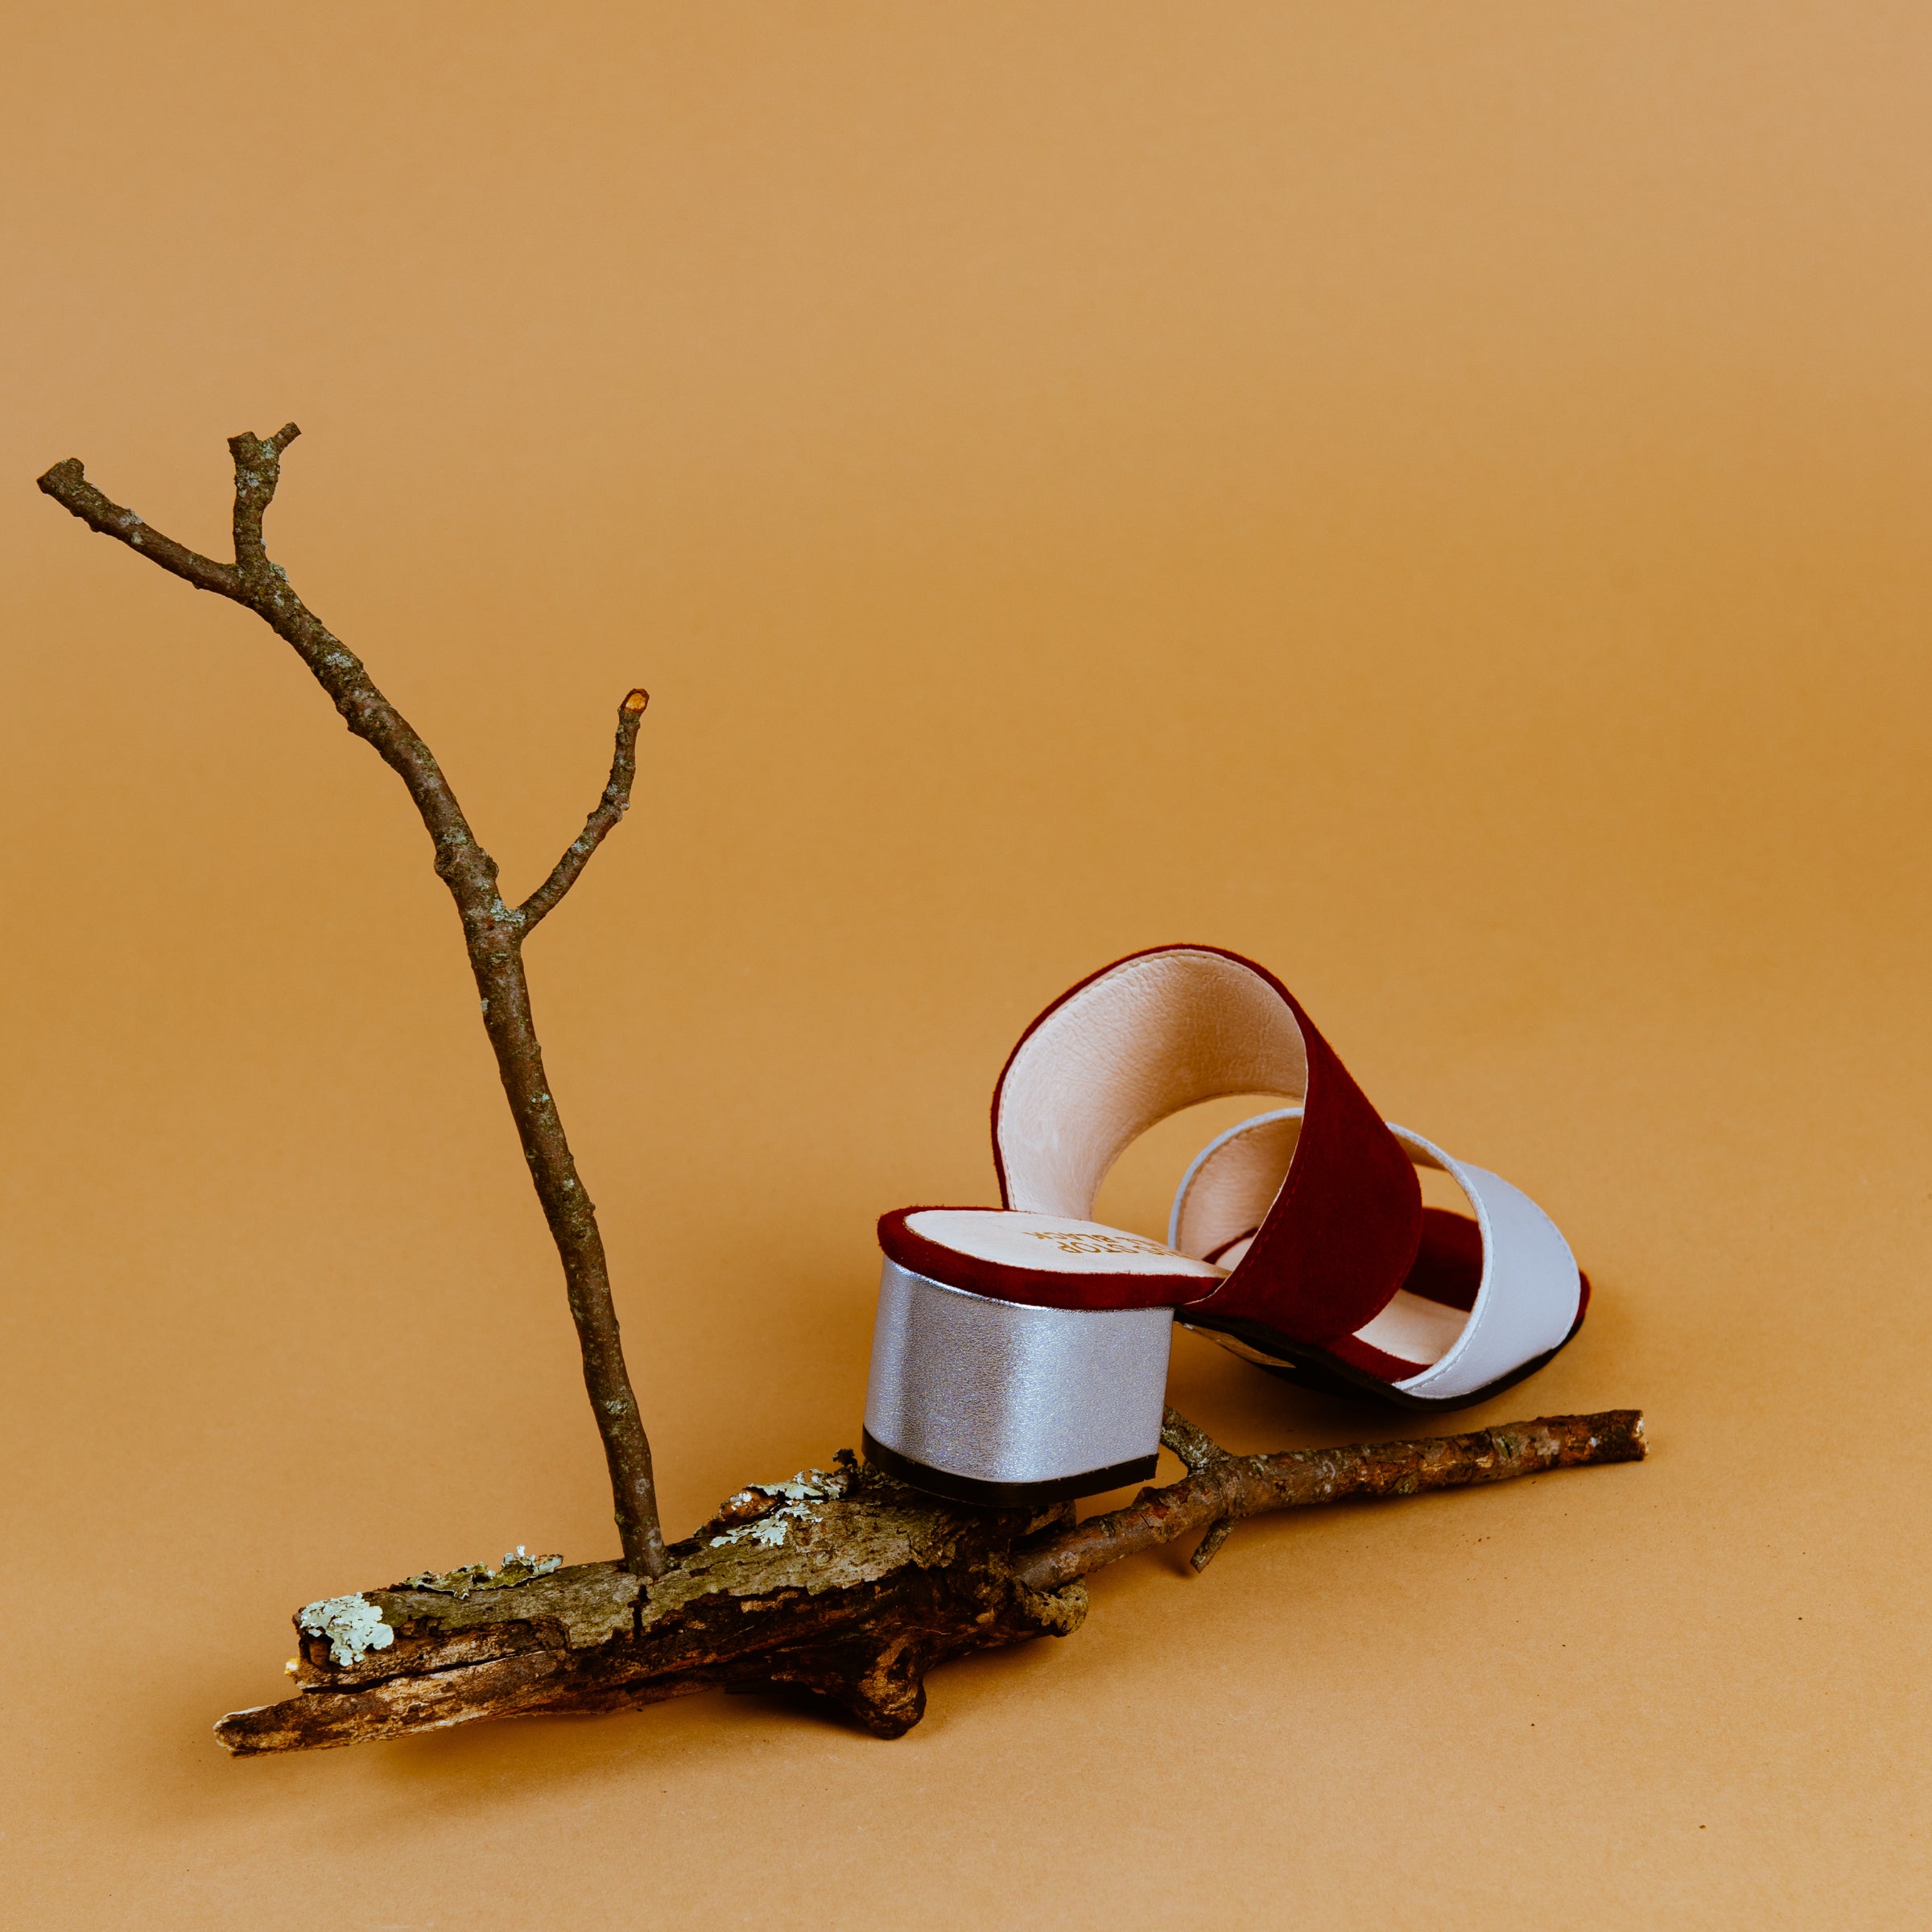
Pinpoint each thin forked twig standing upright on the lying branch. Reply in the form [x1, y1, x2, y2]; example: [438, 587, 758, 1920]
[39, 423, 667, 1576]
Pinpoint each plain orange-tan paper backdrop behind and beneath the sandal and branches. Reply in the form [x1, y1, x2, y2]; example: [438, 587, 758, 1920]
[0, 0, 1932, 1932]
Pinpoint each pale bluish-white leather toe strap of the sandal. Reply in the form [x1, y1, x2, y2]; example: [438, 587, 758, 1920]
[1167, 1107, 1583, 1397]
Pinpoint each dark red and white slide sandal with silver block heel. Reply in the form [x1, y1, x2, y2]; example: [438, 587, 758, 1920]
[865, 947, 1590, 1507]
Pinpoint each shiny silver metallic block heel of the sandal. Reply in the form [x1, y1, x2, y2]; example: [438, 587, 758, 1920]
[865, 1260, 1174, 1509]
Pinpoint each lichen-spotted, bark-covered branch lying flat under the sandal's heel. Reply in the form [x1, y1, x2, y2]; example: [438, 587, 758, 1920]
[214, 1409, 1644, 1757]
